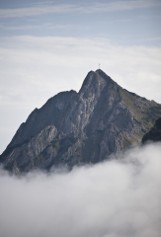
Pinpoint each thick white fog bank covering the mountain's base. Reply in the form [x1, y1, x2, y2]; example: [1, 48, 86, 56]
[0, 143, 161, 237]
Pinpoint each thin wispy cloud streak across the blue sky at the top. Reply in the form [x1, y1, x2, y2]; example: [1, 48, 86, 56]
[0, 0, 161, 18]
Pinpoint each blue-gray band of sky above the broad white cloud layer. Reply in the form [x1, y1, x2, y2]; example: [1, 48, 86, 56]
[0, 0, 161, 45]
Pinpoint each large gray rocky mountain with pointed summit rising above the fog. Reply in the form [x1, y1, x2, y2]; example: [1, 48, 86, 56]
[0, 69, 161, 173]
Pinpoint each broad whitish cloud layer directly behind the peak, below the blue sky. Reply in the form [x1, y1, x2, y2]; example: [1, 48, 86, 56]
[0, 36, 161, 151]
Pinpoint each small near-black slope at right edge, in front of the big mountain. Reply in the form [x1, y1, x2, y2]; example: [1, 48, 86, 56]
[142, 118, 161, 144]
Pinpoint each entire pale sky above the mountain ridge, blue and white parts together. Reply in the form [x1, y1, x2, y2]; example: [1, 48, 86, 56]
[0, 0, 161, 153]
